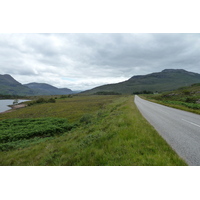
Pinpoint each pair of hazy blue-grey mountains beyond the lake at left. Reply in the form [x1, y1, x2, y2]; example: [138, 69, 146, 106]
[0, 74, 74, 96]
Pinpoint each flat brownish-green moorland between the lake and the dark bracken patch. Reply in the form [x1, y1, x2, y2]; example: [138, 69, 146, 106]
[0, 95, 118, 122]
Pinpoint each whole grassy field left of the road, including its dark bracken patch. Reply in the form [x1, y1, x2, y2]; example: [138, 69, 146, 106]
[0, 95, 186, 166]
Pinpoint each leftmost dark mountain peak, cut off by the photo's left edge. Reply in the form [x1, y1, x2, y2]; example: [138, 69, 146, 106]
[0, 74, 34, 96]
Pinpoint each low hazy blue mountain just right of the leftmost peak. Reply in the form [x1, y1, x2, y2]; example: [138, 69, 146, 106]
[24, 83, 73, 95]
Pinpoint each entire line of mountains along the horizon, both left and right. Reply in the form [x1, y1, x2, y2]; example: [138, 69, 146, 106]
[0, 69, 200, 96]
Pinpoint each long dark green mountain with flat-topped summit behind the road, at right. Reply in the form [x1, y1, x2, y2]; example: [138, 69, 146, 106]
[82, 69, 200, 94]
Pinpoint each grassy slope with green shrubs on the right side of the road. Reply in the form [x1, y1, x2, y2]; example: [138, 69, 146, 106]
[141, 83, 200, 114]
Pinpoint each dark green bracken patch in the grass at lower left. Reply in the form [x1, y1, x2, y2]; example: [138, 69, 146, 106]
[0, 118, 76, 151]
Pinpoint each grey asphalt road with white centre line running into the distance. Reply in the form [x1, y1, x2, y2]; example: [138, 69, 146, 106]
[135, 96, 200, 166]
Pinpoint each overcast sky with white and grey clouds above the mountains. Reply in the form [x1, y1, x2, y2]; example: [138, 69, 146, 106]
[0, 33, 200, 90]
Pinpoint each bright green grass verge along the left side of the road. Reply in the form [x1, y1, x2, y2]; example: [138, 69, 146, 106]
[0, 96, 186, 166]
